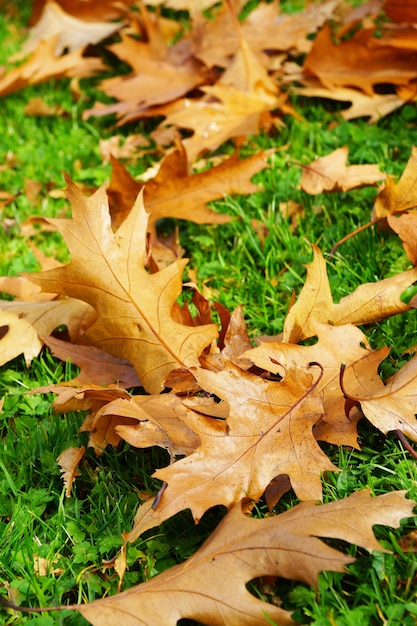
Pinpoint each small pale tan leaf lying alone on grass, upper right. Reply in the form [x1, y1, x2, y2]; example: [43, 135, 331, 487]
[301, 146, 385, 195]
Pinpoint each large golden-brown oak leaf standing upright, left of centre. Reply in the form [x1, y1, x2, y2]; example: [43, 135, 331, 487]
[30, 180, 217, 393]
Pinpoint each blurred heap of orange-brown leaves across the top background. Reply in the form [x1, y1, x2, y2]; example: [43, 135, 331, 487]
[0, 0, 417, 164]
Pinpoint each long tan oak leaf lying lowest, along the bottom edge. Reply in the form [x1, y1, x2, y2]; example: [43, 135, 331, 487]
[75, 491, 414, 626]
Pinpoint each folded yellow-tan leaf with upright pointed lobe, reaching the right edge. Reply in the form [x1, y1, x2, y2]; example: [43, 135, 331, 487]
[283, 245, 417, 343]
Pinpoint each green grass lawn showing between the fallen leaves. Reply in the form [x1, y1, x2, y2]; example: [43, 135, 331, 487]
[0, 2, 417, 626]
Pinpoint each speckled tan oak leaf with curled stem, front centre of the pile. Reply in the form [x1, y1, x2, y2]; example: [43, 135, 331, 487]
[145, 364, 336, 523]
